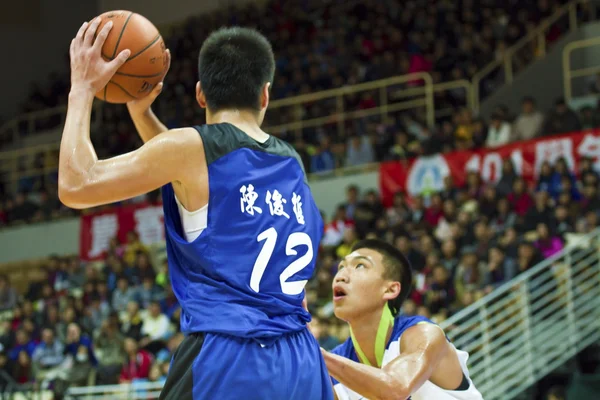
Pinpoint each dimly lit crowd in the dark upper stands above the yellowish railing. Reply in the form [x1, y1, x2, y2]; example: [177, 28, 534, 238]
[12, 0, 592, 130]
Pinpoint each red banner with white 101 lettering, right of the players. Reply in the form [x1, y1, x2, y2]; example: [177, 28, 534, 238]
[379, 129, 600, 206]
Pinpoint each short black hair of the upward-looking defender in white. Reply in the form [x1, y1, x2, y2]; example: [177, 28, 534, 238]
[352, 239, 413, 316]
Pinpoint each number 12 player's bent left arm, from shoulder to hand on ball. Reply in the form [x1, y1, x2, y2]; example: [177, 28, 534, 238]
[58, 18, 204, 208]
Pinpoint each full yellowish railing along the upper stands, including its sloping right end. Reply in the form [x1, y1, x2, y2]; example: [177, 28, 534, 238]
[0, 0, 591, 194]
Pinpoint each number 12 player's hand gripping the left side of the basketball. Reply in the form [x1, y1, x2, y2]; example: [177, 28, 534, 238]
[69, 18, 131, 94]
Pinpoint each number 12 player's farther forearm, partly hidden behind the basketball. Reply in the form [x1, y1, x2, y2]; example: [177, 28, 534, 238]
[127, 50, 171, 143]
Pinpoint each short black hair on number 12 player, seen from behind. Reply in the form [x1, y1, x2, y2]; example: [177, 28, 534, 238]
[198, 27, 275, 112]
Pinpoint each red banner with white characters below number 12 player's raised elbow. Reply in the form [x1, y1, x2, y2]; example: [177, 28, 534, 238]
[79, 204, 165, 261]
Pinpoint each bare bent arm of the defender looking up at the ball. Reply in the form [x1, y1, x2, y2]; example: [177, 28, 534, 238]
[324, 324, 450, 400]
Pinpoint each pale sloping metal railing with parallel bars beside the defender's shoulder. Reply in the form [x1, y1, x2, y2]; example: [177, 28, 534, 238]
[441, 228, 600, 400]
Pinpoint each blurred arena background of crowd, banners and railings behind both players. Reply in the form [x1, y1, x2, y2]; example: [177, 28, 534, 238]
[0, 0, 600, 400]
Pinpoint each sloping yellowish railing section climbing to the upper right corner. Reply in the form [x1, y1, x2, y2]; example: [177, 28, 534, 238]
[471, 0, 595, 113]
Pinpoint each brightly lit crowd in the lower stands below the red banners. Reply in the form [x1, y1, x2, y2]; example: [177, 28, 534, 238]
[0, 149, 600, 394]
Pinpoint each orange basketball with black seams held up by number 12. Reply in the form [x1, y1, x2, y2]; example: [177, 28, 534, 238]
[92, 10, 167, 103]
